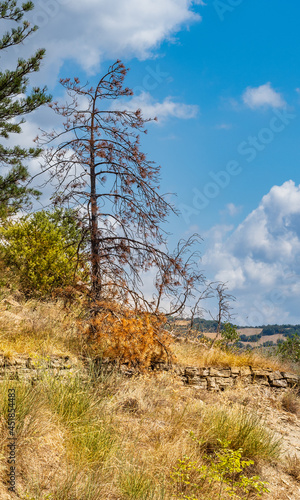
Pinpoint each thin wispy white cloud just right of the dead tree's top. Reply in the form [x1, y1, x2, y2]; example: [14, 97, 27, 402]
[113, 92, 199, 123]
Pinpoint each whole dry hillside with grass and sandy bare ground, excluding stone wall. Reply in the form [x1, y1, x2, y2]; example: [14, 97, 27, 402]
[0, 298, 300, 500]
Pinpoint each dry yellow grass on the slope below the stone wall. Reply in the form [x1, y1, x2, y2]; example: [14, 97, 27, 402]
[0, 366, 292, 500]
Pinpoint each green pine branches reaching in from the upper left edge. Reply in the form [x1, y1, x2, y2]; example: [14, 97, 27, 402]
[0, 0, 51, 219]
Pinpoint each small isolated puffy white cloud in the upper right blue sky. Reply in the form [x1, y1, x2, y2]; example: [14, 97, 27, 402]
[242, 82, 286, 109]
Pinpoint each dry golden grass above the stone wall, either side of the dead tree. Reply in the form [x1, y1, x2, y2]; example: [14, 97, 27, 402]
[0, 297, 291, 370]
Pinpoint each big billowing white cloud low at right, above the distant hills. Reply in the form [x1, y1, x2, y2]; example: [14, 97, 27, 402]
[203, 180, 300, 325]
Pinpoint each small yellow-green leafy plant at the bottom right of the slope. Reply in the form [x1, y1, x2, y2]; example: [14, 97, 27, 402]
[171, 440, 269, 500]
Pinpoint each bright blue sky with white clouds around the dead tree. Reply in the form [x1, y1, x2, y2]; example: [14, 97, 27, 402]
[5, 0, 300, 325]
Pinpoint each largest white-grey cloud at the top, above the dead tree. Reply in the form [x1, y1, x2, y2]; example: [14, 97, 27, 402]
[10, 0, 204, 85]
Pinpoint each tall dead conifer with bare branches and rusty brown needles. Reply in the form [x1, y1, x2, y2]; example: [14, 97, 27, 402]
[37, 60, 203, 313]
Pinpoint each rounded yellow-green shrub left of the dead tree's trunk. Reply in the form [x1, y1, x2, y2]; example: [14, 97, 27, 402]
[0, 209, 84, 296]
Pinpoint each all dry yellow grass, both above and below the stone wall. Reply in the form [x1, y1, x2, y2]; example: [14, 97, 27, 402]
[0, 294, 298, 500]
